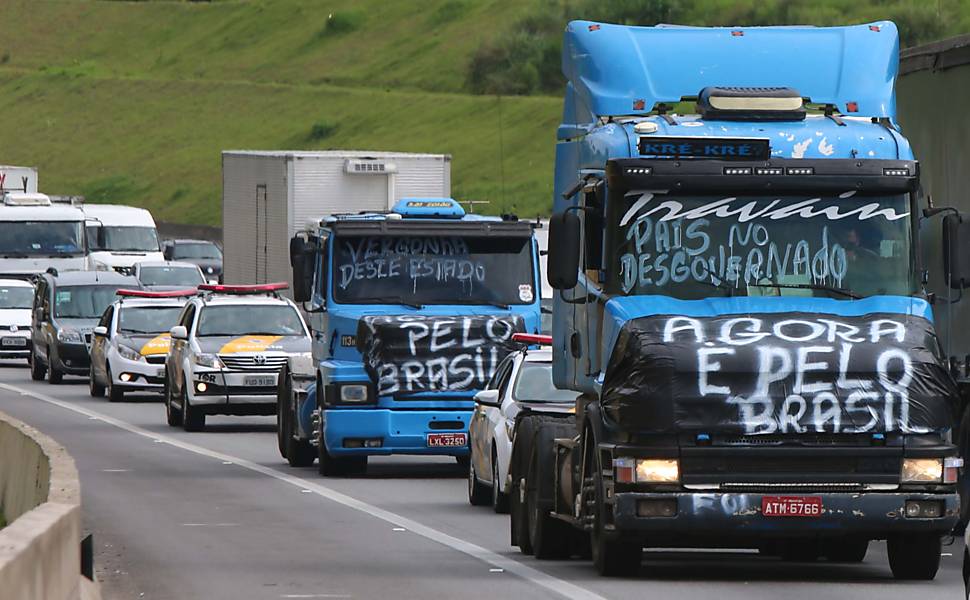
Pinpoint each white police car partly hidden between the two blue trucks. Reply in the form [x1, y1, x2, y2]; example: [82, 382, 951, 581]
[468, 333, 578, 512]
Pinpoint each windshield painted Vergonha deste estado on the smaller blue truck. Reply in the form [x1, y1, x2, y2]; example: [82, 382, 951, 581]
[331, 236, 536, 305]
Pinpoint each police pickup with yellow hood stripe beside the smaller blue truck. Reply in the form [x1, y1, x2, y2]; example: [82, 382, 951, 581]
[165, 283, 310, 431]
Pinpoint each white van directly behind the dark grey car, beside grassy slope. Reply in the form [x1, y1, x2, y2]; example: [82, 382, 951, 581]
[83, 204, 165, 275]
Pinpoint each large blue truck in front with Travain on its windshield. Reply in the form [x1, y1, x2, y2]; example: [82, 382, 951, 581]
[510, 21, 970, 579]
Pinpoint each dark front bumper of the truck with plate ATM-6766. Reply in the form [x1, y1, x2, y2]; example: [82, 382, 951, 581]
[613, 490, 960, 545]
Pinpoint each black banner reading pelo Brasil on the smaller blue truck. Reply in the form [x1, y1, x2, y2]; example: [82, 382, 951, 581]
[357, 315, 524, 395]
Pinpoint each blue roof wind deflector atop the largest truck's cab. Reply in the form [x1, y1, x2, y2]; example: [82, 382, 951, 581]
[562, 21, 899, 119]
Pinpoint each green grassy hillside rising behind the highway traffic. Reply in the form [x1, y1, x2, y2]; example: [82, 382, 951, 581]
[0, 0, 970, 224]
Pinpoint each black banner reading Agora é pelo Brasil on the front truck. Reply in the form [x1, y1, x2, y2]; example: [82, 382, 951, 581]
[602, 313, 957, 434]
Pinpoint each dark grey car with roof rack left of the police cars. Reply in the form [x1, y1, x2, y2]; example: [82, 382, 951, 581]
[28, 271, 140, 383]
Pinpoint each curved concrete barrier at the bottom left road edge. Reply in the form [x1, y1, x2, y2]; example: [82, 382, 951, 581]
[0, 412, 100, 600]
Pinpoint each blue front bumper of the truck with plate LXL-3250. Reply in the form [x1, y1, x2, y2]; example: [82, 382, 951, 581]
[323, 408, 472, 456]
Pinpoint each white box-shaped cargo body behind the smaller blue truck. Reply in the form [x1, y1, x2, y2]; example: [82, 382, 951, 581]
[222, 150, 451, 285]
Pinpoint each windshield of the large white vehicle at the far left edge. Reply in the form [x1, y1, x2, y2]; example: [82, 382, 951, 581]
[0, 221, 84, 258]
